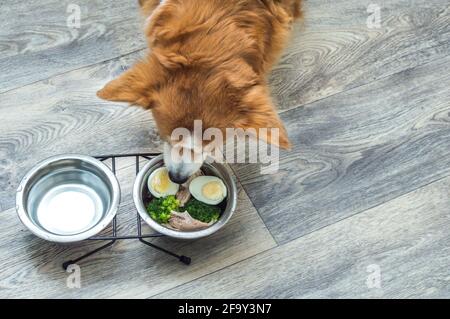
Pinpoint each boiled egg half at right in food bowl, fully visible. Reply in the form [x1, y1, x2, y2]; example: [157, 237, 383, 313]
[189, 176, 227, 205]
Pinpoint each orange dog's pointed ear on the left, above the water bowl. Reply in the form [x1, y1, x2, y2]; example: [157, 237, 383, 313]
[97, 62, 153, 108]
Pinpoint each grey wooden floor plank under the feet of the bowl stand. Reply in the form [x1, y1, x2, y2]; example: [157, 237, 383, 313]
[0, 160, 275, 298]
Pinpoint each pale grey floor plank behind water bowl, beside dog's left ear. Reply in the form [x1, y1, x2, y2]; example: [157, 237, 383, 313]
[0, 52, 155, 210]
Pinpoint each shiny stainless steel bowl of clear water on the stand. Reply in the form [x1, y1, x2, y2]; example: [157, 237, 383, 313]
[16, 155, 120, 243]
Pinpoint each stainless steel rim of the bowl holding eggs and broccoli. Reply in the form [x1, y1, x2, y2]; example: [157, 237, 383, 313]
[133, 155, 237, 239]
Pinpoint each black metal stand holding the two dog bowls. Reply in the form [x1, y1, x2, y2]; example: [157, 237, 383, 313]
[62, 153, 191, 270]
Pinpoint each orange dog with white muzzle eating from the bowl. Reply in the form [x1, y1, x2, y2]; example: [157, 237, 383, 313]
[97, 0, 302, 184]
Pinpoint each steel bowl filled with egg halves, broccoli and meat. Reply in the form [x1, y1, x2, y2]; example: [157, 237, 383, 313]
[134, 156, 236, 239]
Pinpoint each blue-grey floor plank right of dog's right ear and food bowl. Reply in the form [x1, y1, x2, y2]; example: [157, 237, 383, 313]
[233, 57, 450, 243]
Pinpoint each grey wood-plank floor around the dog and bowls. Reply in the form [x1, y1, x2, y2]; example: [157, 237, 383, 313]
[0, 0, 450, 298]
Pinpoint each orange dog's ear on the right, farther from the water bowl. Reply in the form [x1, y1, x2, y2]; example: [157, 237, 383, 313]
[235, 86, 291, 150]
